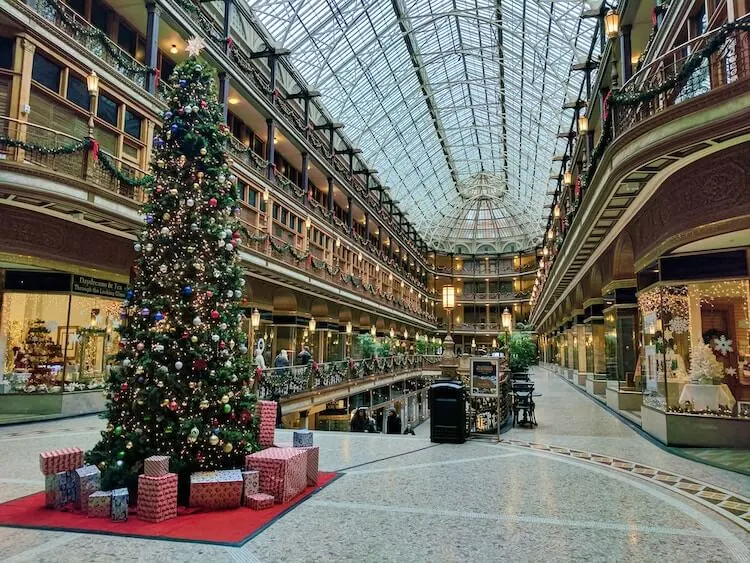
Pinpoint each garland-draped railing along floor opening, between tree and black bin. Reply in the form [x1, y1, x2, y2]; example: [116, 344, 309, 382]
[255, 355, 441, 398]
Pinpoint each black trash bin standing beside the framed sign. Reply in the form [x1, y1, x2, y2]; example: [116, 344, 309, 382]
[429, 380, 466, 444]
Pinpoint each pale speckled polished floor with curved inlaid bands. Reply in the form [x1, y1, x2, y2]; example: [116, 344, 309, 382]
[0, 369, 750, 563]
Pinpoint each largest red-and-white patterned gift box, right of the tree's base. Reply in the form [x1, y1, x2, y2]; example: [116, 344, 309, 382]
[245, 448, 307, 503]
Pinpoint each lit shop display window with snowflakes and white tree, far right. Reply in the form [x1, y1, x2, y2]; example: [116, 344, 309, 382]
[636, 280, 750, 417]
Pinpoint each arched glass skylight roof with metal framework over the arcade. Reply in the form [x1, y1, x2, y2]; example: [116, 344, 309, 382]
[248, 0, 595, 252]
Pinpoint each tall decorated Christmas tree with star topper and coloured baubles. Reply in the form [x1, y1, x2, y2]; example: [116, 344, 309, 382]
[87, 40, 259, 493]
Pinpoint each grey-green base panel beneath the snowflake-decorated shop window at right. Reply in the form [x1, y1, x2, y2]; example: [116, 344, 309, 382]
[641, 405, 750, 448]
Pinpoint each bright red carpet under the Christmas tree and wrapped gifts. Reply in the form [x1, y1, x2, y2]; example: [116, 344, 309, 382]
[0, 472, 338, 546]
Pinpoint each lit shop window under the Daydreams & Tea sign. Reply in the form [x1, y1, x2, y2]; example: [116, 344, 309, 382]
[0, 292, 120, 393]
